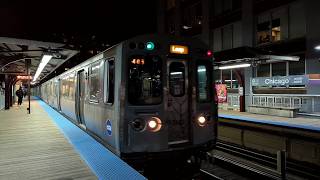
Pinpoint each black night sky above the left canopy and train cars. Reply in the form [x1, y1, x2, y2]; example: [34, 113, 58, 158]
[0, 0, 156, 44]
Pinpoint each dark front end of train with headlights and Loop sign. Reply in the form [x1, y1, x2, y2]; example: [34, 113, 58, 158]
[120, 35, 217, 160]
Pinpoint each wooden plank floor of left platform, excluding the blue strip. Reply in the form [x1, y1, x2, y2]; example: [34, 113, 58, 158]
[0, 101, 98, 180]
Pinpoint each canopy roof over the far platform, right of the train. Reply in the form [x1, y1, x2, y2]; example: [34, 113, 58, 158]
[213, 46, 300, 65]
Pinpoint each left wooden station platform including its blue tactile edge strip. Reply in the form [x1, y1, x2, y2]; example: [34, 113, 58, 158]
[0, 99, 146, 180]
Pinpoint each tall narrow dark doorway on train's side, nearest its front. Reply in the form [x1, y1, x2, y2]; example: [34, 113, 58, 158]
[76, 70, 86, 127]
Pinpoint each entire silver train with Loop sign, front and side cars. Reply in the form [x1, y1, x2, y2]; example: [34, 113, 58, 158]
[40, 35, 217, 162]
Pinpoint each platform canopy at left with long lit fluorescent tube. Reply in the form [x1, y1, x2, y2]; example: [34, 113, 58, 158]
[0, 37, 78, 83]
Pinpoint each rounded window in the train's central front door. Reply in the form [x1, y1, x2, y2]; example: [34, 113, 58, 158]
[169, 62, 185, 97]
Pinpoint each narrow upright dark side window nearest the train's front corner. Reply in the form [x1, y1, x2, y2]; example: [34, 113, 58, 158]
[103, 58, 115, 104]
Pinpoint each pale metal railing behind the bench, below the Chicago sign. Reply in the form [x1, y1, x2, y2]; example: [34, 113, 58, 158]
[251, 94, 320, 115]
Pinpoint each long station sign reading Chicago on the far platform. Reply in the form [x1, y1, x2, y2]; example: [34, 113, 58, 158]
[251, 75, 309, 86]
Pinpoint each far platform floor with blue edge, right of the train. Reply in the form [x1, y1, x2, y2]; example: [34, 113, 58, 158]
[218, 109, 320, 132]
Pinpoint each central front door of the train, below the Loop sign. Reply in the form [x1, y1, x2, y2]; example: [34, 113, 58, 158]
[167, 59, 190, 145]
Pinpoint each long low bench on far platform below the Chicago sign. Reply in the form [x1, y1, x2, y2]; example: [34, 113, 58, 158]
[248, 105, 300, 118]
